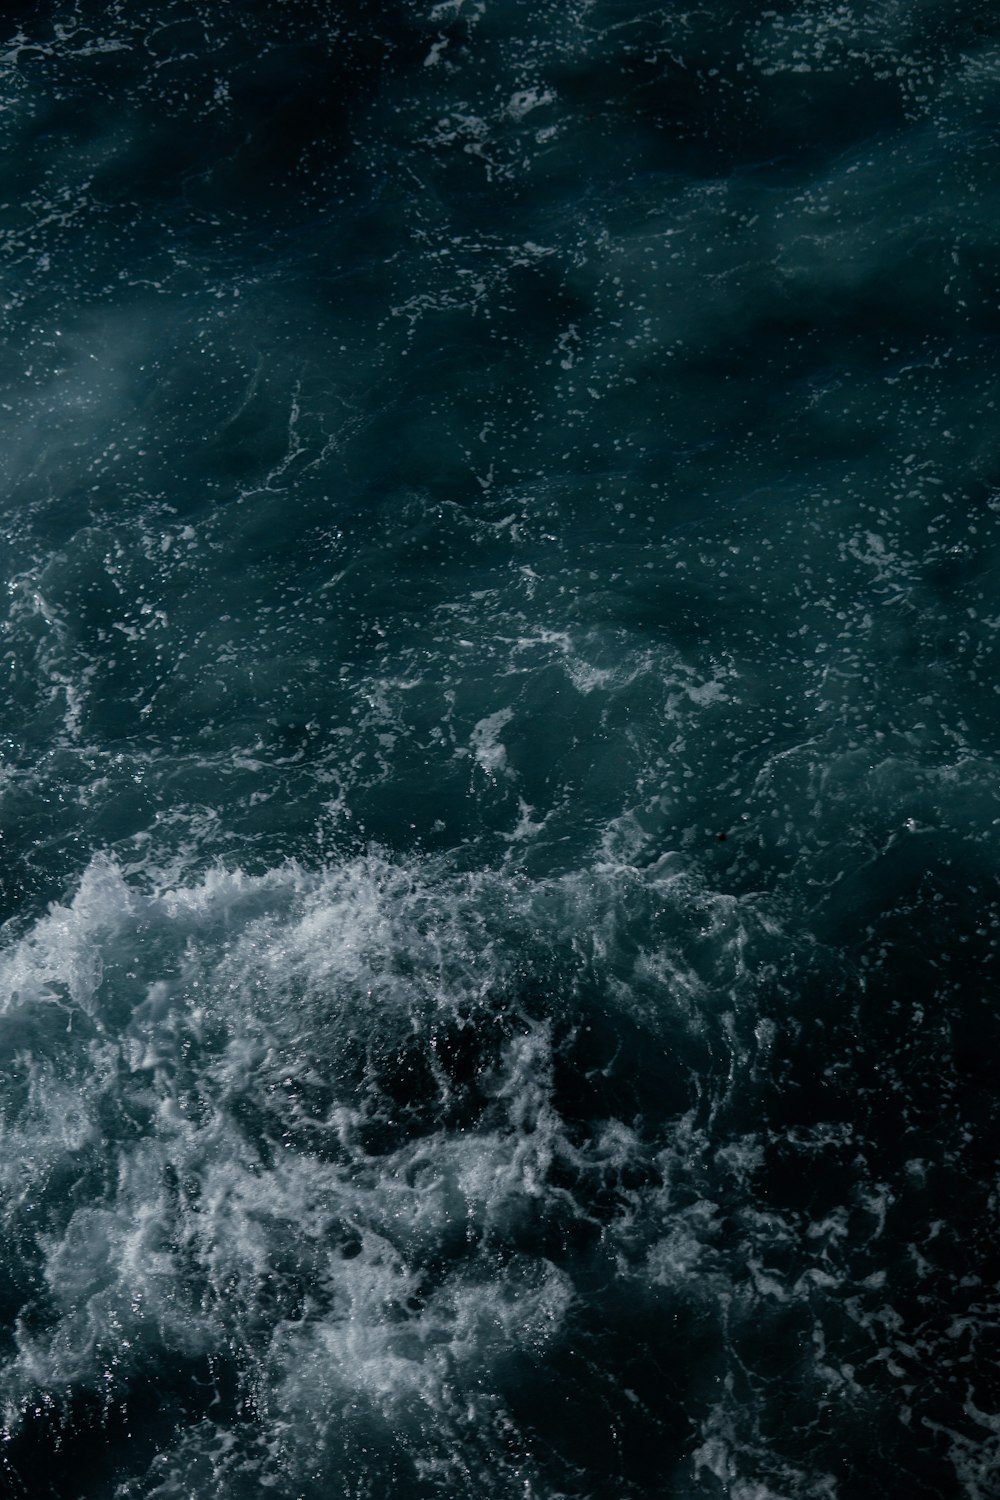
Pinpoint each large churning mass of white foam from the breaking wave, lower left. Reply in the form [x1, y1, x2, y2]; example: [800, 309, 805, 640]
[0, 852, 746, 1494]
